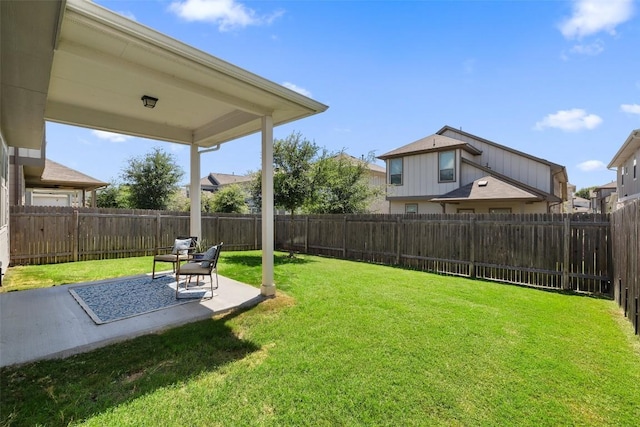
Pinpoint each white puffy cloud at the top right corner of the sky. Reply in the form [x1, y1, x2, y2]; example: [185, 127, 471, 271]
[560, 0, 633, 39]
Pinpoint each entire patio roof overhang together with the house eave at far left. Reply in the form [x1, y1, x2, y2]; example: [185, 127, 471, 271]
[0, 0, 328, 149]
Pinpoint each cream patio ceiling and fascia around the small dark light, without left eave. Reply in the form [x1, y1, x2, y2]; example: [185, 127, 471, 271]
[45, 0, 327, 147]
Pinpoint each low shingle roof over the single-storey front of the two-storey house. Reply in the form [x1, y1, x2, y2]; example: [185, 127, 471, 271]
[431, 176, 542, 202]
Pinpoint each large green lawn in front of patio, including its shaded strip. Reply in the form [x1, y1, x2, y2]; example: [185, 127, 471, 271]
[0, 252, 640, 426]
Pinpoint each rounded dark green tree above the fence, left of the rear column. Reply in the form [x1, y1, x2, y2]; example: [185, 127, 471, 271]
[122, 147, 184, 209]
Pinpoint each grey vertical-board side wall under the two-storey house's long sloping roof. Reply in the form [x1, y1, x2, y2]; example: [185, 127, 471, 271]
[443, 130, 552, 193]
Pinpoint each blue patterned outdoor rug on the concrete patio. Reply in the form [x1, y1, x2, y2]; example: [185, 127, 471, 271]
[69, 276, 215, 325]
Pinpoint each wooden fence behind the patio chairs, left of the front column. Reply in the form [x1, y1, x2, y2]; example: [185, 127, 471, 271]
[10, 206, 262, 265]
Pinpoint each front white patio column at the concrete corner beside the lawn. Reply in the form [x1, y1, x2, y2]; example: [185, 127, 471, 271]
[260, 116, 276, 297]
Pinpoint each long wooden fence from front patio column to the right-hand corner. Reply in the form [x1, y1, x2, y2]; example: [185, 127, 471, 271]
[276, 214, 612, 295]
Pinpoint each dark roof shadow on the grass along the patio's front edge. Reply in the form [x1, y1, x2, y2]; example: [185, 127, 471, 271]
[0, 310, 260, 426]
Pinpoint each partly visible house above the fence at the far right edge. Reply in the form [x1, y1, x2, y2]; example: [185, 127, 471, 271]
[607, 129, 640, 211]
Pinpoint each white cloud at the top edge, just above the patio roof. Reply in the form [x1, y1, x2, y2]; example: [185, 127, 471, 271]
[169, 0, 283, 31]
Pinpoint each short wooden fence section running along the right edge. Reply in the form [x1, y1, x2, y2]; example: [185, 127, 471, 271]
[611, 199, 640, 334]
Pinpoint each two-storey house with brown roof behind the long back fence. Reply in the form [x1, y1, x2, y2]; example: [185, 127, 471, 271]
[378, 126, 568, 214]
